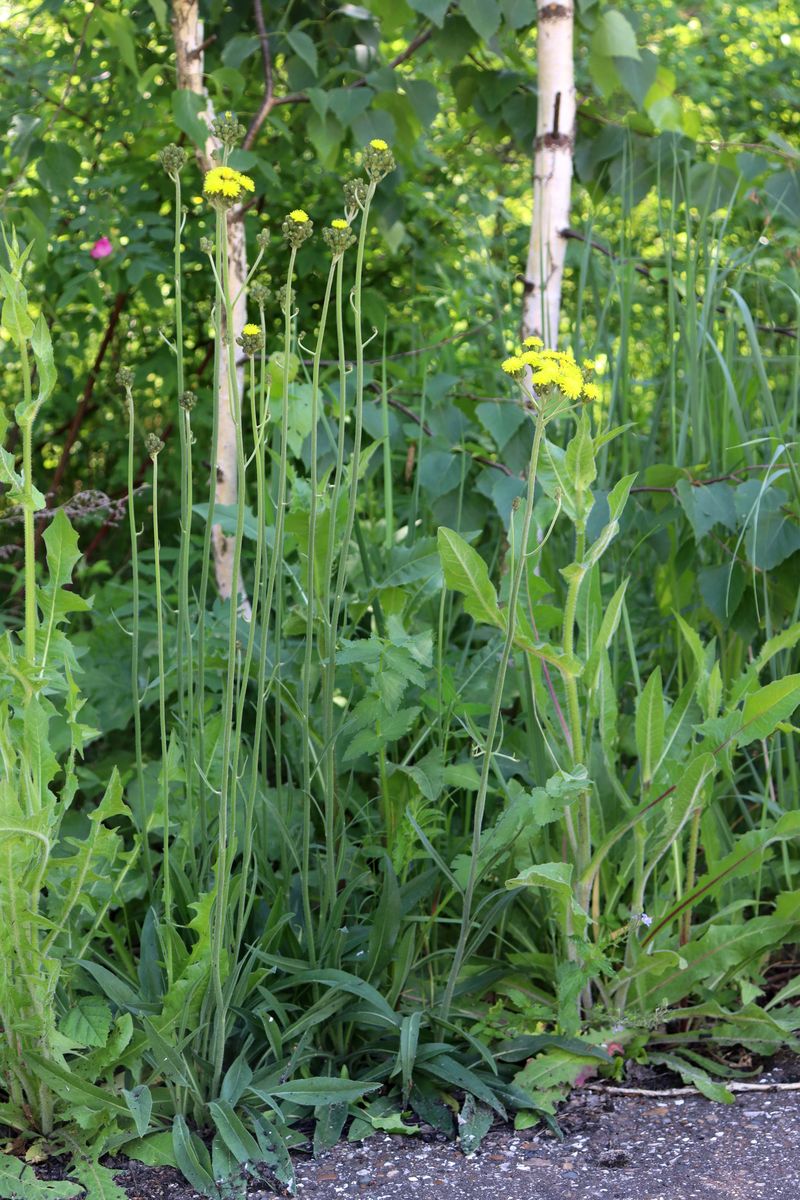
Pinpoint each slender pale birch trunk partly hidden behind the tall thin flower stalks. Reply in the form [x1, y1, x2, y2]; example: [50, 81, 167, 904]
[173, 0, 251, 609]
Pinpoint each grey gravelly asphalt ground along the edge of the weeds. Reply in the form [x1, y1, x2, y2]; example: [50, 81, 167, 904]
[98, 1062, 800, 1200]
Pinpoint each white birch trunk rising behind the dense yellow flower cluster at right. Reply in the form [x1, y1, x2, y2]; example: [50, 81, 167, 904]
[522, 0, 575, 348]
